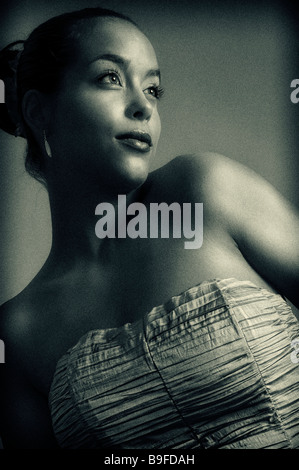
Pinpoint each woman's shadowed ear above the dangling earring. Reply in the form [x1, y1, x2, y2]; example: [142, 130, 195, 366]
[22, 90, 47, 134]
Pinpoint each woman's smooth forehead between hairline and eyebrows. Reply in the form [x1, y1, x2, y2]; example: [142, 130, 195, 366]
[79, 17, 157, 67]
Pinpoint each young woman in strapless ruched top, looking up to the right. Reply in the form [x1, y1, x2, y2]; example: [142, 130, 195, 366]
[0, 8, 299, 449]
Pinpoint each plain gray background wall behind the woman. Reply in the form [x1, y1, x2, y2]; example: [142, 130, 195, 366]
[0, 0, 299, 448]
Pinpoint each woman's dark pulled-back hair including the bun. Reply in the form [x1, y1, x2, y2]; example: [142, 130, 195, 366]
[0, 8, 137, 184]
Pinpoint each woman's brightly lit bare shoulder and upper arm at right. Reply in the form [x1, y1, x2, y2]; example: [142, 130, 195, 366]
[186, 153, 299, 307]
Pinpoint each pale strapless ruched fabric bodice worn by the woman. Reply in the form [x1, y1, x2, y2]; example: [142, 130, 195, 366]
[49, 279, 299, 449]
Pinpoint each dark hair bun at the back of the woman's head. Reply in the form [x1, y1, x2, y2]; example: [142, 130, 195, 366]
[0, 41, 24, 135]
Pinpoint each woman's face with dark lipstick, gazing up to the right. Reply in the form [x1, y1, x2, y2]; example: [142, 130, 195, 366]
[48, 18, 161, 193]
